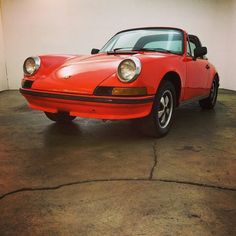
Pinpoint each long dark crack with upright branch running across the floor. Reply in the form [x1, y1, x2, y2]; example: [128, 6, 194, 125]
[0, 142, 236, 201]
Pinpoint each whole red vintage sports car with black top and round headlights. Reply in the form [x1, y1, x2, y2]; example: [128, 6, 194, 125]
[20, 27, 219, 137]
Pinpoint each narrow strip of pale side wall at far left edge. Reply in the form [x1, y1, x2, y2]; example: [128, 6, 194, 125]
[0, 4, 8, 91]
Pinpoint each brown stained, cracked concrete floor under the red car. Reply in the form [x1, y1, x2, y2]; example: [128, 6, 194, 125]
[0, 90, 236, 236]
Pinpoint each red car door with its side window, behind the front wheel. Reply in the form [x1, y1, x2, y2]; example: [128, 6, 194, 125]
[184, 35, 210, 100]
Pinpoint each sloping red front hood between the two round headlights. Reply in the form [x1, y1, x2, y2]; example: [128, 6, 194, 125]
[32, 54, 173, 95]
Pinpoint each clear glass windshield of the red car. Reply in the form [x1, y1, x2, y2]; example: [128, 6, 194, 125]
[100, 28, 183, 54]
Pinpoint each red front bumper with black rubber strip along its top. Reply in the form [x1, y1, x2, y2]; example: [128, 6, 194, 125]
[20, 89, 154, 120]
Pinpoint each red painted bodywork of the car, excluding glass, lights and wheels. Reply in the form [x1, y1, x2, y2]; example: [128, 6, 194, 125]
[21, 27, 216, 119]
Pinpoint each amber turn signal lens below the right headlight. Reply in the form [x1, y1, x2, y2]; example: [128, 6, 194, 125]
[112, 87, 147, 96]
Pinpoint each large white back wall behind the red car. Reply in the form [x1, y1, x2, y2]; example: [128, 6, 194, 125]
[2, 0, 236, 90]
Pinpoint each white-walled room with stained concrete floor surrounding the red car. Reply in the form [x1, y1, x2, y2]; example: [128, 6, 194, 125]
[0, 0, 236, 236]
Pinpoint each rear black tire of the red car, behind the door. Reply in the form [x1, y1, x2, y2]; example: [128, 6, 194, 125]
[199, 78, 219, 110]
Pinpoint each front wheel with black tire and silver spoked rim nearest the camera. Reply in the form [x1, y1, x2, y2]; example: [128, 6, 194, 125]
[142, 80, 176, 138]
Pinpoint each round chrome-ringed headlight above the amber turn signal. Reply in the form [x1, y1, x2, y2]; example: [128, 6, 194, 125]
[117, 57, 141, 83]
